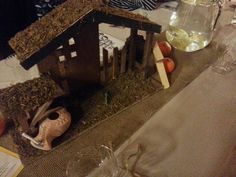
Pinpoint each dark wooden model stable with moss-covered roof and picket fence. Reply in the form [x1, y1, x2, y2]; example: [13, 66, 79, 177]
[9, 0, 164, 89]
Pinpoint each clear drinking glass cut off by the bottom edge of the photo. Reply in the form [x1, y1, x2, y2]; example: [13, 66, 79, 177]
[66, 145, 128, 177]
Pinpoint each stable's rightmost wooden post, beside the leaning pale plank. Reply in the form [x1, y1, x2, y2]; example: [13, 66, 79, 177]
[142, 32, 154, 78]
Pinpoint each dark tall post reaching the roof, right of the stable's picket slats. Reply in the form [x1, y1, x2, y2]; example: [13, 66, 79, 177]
[129, 29, 138, 69]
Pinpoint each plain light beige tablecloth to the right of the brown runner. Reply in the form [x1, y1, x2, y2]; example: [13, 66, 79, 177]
[117, 68, 236, 177]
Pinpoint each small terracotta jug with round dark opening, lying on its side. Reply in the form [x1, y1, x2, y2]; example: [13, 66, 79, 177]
[30, 108, 71, 151]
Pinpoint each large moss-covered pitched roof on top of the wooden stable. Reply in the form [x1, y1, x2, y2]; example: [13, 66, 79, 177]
[9, 0, 161, 69]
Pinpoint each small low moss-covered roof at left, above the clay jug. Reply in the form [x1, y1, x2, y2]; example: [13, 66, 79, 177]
[0, 75, 64, 119]
